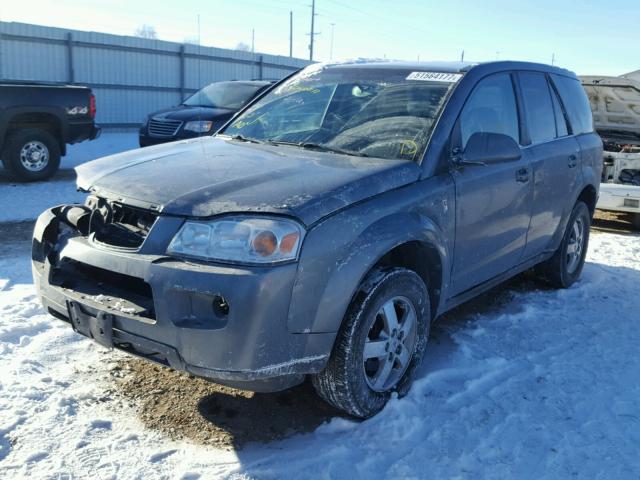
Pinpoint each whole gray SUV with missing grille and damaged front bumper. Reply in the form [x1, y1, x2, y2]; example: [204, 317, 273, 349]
[33, 62, 602, 417]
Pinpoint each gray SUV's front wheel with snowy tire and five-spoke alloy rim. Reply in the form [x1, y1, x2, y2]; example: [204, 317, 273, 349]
[312, 267, 431, 418]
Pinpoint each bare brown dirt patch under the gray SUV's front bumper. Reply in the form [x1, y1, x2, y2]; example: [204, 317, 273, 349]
[110, 358, 340, 450]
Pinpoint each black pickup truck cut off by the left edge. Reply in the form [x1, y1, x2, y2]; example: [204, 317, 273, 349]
[0, 81, 100, 182]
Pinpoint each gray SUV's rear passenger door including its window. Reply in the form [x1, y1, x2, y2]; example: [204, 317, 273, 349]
[517, 72, 581, 260]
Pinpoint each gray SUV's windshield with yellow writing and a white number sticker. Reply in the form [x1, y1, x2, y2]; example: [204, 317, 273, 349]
[221, 65, 461, 160]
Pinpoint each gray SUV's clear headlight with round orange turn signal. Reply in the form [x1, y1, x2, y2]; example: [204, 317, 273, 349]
[167, 217, 304, 263]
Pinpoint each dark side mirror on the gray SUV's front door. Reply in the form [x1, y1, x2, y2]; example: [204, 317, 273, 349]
[458, 132, 522, 165]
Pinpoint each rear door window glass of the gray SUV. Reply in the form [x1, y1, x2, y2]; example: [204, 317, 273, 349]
[518, 72, 556, 144]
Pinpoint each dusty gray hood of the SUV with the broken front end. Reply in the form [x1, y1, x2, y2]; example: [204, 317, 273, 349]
[76, 137, 420, 225]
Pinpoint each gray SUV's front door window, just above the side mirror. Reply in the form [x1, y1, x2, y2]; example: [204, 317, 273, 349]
[460, 73, 519, 148]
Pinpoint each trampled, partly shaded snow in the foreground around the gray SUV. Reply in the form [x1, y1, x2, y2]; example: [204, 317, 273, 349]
[0, 227, 640, 479]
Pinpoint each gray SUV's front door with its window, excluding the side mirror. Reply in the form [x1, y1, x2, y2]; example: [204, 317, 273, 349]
[451, 73, 532, 295]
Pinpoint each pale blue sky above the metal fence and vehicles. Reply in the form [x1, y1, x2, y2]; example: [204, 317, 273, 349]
[0, 0, 640, 75]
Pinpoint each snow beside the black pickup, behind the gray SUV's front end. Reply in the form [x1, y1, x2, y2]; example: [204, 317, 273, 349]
[0, 133, 138, 222]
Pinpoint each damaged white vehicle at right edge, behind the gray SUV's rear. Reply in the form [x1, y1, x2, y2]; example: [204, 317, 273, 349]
[580, 76, 640, 229]
